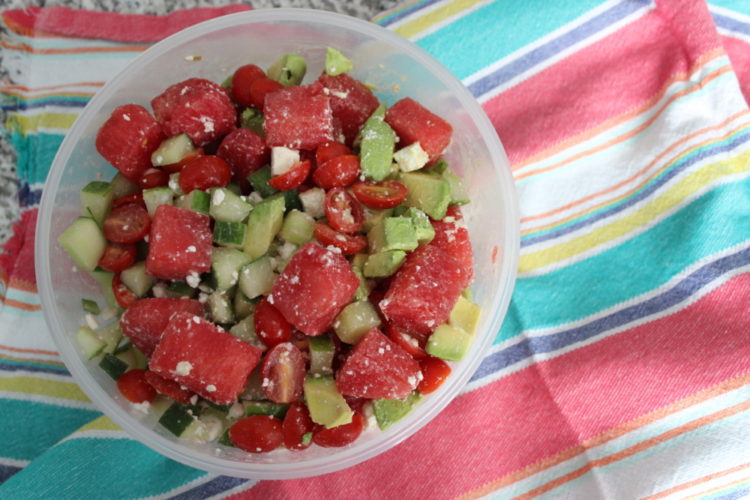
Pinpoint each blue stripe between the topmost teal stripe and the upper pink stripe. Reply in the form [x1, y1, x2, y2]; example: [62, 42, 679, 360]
[468, 0, 651, 97]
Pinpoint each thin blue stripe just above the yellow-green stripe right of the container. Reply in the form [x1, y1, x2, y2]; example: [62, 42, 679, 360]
[521, 131, 750, 248]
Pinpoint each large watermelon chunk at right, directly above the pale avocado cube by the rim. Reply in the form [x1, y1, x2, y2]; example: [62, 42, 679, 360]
[379, 244, 466, 336]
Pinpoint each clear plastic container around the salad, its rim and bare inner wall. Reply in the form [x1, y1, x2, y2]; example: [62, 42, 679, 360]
[36, 9, 519, 479]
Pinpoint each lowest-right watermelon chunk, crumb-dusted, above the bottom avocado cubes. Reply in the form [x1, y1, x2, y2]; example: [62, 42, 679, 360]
[336, 328, 422, 399]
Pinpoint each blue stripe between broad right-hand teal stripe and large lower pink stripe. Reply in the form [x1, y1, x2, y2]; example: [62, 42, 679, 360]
[471, 244, 750, 380]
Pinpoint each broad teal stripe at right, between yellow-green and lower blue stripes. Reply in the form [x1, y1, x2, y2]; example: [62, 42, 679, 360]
[495, 178, 750, 343]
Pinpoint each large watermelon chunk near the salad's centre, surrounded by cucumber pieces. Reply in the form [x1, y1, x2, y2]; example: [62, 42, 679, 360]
[268, 243, 359, 335]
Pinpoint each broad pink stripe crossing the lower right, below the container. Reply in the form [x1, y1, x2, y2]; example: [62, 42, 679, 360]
[235, 273, 750, 499]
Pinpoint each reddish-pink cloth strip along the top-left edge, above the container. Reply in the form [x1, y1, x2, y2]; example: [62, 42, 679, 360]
[3, 4, 250, 43]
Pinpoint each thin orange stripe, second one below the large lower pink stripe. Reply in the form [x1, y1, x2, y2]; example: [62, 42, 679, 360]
[515, 401, 750, 499]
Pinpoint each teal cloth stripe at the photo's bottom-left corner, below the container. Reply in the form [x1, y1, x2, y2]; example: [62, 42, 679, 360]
[0, 438, 206, 500]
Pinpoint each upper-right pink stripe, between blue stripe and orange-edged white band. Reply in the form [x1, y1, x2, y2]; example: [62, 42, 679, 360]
[484, 0, 720, 164]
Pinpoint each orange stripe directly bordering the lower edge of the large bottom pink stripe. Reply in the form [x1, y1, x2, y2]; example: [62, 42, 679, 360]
[459, 373, 750, 499]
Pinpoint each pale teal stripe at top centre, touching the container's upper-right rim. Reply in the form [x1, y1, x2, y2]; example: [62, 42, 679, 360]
[417, 0, 604, 79]
